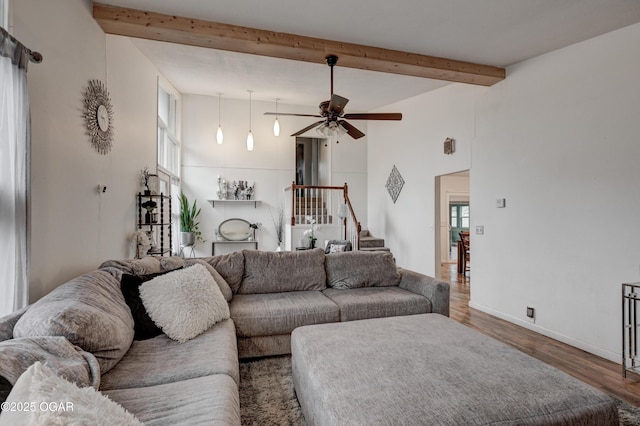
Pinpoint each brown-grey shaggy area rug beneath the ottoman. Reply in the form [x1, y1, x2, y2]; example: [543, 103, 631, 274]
[240, 355, 640, 426]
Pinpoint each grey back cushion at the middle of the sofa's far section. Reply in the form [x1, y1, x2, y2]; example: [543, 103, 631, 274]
[238, 248, 326, 294]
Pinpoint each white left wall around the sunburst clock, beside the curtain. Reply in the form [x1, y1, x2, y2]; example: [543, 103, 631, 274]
[12, 0, 157, 301]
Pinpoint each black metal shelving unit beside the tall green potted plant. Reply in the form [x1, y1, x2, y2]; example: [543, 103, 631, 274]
[138, 192, 172, 256]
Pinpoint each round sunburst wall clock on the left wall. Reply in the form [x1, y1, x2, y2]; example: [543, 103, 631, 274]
[84, 80, 113, 155]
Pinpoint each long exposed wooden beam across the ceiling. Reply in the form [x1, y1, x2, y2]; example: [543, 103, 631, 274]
[93, 3, 506, 86]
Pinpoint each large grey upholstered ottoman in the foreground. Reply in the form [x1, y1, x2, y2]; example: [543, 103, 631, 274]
[291, 314, 618, 425]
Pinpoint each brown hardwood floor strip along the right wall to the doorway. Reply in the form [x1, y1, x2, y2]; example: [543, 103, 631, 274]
[442, 264, 640, 407]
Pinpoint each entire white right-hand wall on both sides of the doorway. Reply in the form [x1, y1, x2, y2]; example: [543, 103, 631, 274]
[369, 24, 640, 361]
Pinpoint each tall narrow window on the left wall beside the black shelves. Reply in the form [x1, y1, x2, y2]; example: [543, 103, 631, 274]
[158, 81, 180, 252]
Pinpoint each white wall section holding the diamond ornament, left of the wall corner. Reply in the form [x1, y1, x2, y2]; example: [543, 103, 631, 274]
[368, 85, 478, 276]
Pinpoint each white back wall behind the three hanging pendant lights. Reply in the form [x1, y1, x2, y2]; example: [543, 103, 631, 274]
[182, 93, 367, 256]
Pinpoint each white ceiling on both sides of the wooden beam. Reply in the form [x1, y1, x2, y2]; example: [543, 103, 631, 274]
[100, 0, 640, 112]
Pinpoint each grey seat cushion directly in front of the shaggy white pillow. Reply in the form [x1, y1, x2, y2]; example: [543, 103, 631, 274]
[100, 320, 239, 390]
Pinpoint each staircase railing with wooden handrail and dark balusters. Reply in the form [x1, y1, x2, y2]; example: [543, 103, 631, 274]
[291, 182, 362, 250]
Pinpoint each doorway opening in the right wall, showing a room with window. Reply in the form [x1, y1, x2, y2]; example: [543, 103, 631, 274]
[434, 170, 471, 278]
